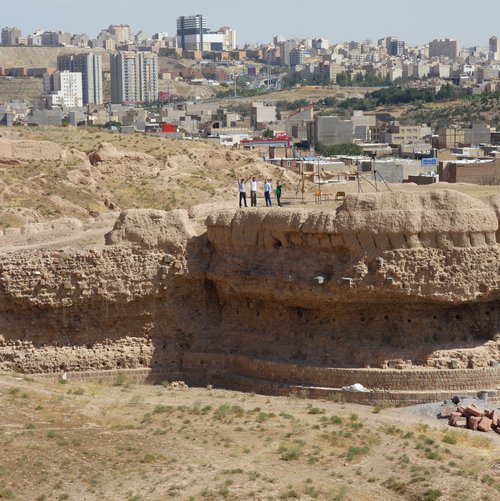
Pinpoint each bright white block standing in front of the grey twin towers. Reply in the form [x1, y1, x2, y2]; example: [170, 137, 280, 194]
[42, 71, 83, 108]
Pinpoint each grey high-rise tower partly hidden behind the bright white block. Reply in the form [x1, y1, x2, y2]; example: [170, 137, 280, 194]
[57, 54, 104, 105]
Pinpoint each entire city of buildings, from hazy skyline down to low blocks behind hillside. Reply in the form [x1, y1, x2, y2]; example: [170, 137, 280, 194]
[0, 14, 500, 184]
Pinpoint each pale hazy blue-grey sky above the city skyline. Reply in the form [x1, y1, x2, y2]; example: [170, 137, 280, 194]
[0, 0, 500, 46]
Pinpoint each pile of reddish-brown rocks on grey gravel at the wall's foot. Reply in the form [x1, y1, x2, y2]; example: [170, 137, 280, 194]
[440, 404, 500, 434]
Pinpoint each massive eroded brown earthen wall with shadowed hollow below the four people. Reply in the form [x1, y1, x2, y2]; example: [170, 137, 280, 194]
[0, 191, 500, 400]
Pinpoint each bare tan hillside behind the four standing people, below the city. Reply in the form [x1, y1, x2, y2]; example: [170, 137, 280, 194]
[0, 127, 298, 231]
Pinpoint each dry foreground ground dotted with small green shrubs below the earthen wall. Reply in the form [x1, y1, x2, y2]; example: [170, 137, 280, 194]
[0, 374, 500, 501]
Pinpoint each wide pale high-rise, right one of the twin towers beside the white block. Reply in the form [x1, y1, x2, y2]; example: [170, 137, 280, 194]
[110, 52, 158, 104]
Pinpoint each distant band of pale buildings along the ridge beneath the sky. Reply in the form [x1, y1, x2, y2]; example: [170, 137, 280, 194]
[4, 14, 500, 94]
